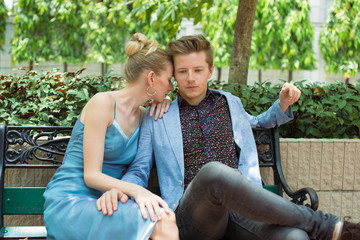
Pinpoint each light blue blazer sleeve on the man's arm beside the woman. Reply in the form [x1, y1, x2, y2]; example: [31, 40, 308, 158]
[121, 109, 154, 188]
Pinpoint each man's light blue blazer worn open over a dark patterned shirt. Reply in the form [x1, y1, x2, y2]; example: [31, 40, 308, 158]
[122, 90, 293, 210]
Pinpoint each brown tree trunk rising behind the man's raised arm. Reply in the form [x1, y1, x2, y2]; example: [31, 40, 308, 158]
[229, 0, 258, 84]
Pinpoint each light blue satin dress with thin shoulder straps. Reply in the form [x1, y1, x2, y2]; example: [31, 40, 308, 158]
[44, 104, 155, 240]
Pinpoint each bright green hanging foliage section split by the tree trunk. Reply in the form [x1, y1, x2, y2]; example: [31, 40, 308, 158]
[201, 0, 315, 80]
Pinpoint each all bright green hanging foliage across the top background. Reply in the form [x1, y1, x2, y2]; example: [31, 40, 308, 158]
[0, 0, 360, 83]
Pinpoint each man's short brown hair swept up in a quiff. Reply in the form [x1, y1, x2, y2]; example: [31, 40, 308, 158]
[166, 34, 214, 68]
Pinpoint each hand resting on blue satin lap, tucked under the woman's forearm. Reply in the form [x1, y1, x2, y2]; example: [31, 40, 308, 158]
[96, 188, 128, 216]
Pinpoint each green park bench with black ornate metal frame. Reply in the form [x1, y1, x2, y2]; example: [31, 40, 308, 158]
[0, 125, 318, 239]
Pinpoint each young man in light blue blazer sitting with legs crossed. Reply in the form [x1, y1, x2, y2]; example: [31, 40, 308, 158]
[102, 35, 360, 240]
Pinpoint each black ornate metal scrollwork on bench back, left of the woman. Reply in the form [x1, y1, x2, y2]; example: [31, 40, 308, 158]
[5, 127, 71, 164]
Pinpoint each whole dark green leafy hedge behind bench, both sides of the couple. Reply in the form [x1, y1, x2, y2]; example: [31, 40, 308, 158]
[0, 70, 360, 138]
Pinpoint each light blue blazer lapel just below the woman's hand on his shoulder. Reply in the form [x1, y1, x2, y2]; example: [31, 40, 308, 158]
[163, 98, 184, 175]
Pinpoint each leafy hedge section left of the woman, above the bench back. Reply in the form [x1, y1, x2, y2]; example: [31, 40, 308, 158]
[0, 69, 121, 126]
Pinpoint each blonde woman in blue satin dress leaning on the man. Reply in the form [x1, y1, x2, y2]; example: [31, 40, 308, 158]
[44, 33, 178, 240]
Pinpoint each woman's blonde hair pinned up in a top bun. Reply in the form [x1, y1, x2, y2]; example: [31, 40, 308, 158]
[124, 33, 171, 83]
